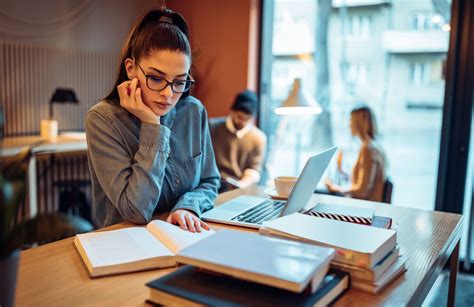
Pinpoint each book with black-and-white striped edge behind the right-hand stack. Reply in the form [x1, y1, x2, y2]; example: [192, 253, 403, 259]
[305, 203, 375, 225]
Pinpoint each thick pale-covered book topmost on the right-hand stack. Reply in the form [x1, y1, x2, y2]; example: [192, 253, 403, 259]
[260, 213, 397, 268]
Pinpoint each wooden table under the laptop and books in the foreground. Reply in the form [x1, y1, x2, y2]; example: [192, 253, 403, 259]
[16, 187, 462, 306]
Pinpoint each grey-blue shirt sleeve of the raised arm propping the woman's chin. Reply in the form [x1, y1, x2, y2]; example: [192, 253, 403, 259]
[86, 111, 170, 224]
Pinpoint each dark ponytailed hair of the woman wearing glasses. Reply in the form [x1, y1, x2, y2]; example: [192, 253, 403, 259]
[105, 9, 191, 103]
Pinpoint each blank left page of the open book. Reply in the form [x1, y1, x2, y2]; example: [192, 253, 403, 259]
[78, 227, 173, 267]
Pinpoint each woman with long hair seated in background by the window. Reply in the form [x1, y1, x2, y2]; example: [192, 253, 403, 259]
[326, 106, 386, 201]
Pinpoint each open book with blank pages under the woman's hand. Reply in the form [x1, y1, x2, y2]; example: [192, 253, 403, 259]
[74, 220, 215, 277]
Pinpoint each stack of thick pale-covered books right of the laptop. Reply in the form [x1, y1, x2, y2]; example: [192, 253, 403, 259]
[260, 213, 405, 294]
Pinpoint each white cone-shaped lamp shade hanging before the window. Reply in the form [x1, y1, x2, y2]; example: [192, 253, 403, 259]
[274, 78, 323, 115]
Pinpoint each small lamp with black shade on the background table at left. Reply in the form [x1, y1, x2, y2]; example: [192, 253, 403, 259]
[40, 87, 79, 139]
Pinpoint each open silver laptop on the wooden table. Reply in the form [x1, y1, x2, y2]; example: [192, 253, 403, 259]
[202, 147, 337, 228]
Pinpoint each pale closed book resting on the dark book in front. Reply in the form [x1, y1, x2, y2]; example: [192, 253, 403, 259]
[176, 229, 335, 292]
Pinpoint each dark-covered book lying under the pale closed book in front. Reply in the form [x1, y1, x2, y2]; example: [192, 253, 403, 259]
[146, 266, 349, 306]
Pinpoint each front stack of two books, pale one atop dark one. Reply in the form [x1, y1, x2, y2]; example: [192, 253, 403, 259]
[147, 230, 349, 306]
